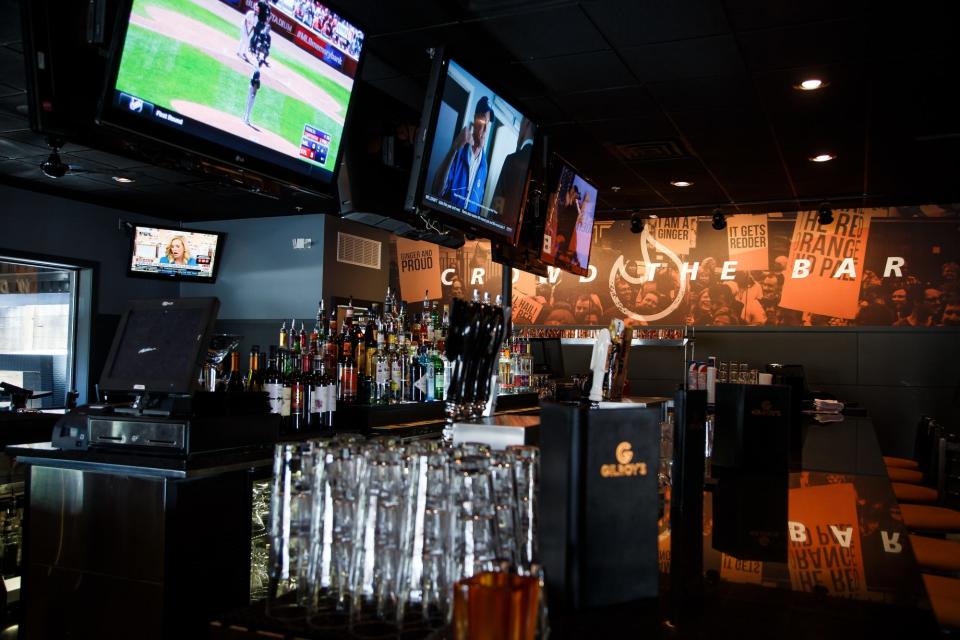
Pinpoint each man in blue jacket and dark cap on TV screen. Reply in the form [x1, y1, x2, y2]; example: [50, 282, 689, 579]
[439, 96, 493, 214]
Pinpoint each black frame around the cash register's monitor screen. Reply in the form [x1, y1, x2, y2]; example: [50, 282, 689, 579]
[99, 296, 220, 394]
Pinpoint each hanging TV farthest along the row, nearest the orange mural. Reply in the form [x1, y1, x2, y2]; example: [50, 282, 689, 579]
[540, 156, 597, 276]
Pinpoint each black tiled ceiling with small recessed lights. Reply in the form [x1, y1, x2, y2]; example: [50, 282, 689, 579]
[0, 0, 960, 219]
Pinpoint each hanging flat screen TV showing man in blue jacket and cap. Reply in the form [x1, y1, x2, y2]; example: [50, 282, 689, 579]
[407, 53, 537, 242]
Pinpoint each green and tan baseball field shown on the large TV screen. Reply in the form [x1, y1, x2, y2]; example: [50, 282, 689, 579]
[117, 0, 353, 170]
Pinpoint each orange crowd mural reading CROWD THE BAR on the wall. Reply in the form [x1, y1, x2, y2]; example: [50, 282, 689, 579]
[393, 205, 960, 327]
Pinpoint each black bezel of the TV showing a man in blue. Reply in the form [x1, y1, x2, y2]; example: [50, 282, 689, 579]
[408, 51, 541, 244]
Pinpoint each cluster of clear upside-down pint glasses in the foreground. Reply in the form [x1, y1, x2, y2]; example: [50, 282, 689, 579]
[267, 434, 540, 624]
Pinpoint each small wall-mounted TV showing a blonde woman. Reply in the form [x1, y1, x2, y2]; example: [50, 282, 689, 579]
[127, 225, 226, 282]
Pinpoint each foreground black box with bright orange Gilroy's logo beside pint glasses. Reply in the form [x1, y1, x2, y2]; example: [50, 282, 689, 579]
[540, 403, 661, 609]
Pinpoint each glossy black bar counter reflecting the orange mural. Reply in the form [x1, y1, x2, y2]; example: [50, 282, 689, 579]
[211, 410, 937, 640]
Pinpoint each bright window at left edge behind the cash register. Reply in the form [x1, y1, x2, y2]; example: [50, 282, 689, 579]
[0, 258, 76, 409]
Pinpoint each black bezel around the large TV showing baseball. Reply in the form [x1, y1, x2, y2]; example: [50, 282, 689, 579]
[96, 0, 369, 195]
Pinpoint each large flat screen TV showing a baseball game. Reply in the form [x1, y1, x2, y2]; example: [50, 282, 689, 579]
[100, 0, 364, 190]
